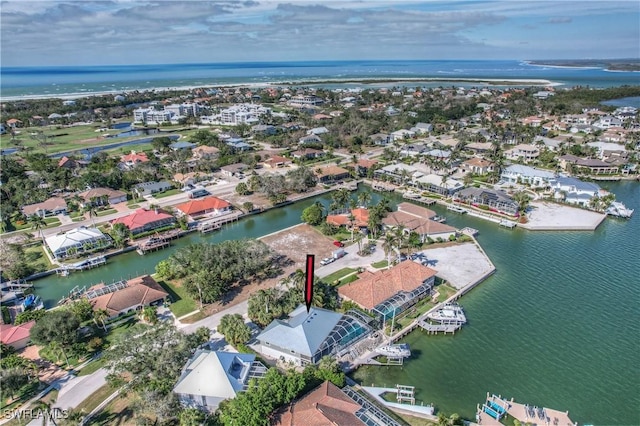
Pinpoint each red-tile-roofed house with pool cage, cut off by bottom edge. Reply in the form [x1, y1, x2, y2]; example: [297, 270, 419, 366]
[271, 381, 399, 426]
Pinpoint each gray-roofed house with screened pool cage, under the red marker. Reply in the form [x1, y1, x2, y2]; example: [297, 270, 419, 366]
[256, 305, 371, 366]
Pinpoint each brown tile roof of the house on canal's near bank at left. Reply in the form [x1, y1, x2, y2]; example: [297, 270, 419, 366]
[91, 275, 169, 316]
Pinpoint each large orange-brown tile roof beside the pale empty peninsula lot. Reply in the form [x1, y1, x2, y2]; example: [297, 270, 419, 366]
[338, 261, 436, 310]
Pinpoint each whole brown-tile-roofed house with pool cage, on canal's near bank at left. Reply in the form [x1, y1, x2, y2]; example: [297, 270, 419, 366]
[90, 275, 169, 317]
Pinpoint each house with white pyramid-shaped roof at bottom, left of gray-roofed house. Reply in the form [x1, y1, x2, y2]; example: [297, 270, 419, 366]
[173, 349, 267, 412]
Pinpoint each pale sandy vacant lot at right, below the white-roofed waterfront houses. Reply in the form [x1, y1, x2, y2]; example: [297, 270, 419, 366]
[519, 202, 606, 231]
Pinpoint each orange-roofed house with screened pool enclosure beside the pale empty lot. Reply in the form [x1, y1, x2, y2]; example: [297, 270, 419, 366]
[338, 260, 436, 319]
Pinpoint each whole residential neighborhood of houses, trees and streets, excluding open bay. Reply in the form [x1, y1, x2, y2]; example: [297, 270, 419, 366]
[0, 84, 640, 425]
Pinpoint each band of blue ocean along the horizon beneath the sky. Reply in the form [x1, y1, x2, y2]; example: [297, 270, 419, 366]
[0, 60, 639, 100]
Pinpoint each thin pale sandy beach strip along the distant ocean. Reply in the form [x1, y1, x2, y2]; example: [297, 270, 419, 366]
[2, 77, 562, 102]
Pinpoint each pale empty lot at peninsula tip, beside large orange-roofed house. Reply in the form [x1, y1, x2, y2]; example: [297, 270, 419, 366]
[422, 243, 495, 289]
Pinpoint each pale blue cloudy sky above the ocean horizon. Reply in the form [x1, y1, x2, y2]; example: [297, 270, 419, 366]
[0, 0, 640, 66]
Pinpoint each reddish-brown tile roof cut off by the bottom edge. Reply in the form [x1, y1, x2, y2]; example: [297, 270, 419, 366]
[271, 382, 363, 426]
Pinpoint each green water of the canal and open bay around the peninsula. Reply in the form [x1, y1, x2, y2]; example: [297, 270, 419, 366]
[34, 182, 640, 425]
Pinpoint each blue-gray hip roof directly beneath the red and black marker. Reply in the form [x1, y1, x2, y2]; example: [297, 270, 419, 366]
[257, 305, 342, 357]
